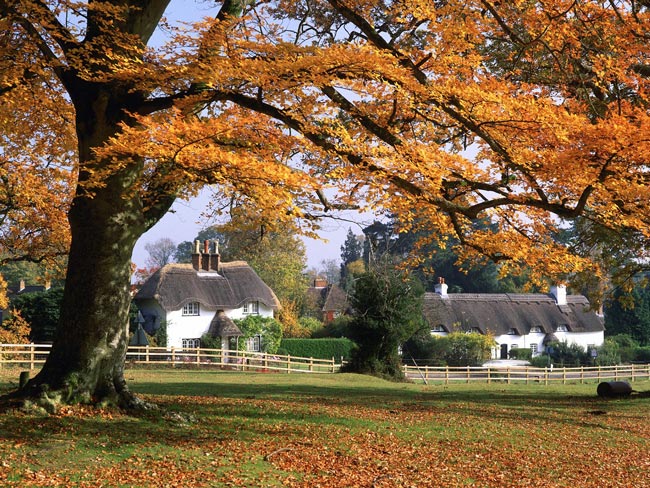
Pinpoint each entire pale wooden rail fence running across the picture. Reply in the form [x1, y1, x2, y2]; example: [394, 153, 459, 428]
[0, 344, 650, 385]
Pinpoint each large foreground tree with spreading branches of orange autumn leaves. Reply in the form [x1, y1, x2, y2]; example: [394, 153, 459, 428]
[0, 0, 650, 404]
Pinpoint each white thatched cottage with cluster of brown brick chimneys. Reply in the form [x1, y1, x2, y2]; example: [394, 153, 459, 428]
[134, 241, 279, 349]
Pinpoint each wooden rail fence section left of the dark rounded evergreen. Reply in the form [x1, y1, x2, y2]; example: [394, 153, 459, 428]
[0, 344, 341, 373]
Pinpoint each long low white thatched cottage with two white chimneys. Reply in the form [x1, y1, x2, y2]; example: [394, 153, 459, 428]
[424, 279, 605, 359]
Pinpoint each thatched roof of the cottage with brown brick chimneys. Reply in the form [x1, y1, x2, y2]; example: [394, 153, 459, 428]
[135, 261, 280, 310]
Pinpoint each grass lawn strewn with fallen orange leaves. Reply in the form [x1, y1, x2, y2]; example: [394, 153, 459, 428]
[0, 370, 650, 488]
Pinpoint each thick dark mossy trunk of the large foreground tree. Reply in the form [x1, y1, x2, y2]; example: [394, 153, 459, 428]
[19, 87, 158, 408]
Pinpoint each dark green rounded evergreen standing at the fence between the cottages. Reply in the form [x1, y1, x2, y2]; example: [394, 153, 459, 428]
[344, 259, 424, 380]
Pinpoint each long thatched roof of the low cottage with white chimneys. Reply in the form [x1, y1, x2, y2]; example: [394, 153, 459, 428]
[424, 293, 605, 335]
